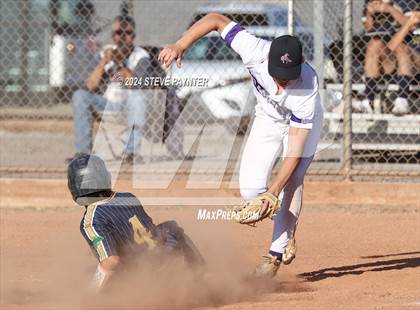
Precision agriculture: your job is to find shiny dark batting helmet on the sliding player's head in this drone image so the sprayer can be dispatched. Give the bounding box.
[67,153,111,205]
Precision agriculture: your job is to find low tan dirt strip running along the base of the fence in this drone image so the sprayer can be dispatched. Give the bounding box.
[0,178,420,209]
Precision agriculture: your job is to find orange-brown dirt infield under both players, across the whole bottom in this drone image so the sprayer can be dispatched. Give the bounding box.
[0,179,420,309]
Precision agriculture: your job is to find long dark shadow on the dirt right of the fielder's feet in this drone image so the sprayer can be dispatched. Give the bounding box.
[299,253,420,282]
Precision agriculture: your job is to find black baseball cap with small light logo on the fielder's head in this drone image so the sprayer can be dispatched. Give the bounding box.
[268,35,303,80]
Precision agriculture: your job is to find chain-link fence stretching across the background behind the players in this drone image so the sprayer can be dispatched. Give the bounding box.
[0,0,420,179]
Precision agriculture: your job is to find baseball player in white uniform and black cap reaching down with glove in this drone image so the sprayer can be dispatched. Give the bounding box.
[159,13,323,277]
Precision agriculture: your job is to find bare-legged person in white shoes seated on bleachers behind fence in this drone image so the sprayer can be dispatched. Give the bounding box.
[361,0,417,114]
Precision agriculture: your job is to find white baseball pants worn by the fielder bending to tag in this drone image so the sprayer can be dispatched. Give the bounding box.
[239,110,323,253]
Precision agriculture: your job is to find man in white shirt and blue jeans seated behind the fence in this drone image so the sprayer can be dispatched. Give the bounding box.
[72,16,153,161]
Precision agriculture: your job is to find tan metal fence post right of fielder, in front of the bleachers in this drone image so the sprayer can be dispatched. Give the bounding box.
[343,0,353,180]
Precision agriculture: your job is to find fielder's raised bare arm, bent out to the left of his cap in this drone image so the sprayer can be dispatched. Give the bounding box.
[159,13,231,67]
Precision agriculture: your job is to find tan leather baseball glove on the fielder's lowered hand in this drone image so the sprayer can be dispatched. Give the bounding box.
[234,192,280,225]
